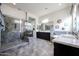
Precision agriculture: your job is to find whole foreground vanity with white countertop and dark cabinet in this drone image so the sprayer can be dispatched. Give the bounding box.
[52,35,79,56]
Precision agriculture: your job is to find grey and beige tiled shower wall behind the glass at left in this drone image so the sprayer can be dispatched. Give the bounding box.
[1,16,20,45]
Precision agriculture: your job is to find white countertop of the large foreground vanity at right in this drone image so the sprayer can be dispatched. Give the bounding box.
[52,35,79,48]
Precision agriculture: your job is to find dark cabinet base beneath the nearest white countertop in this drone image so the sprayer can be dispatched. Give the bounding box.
[54,42,79,56]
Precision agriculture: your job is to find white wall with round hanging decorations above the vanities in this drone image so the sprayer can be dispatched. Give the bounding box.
[38,7,72,31]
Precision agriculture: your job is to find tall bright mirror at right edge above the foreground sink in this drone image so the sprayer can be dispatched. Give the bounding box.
[72,4,79,34]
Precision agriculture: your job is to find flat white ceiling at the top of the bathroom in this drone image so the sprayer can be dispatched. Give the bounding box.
[6,3,71,17]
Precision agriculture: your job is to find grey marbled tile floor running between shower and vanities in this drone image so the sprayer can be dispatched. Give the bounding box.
[0,37,54,56]
